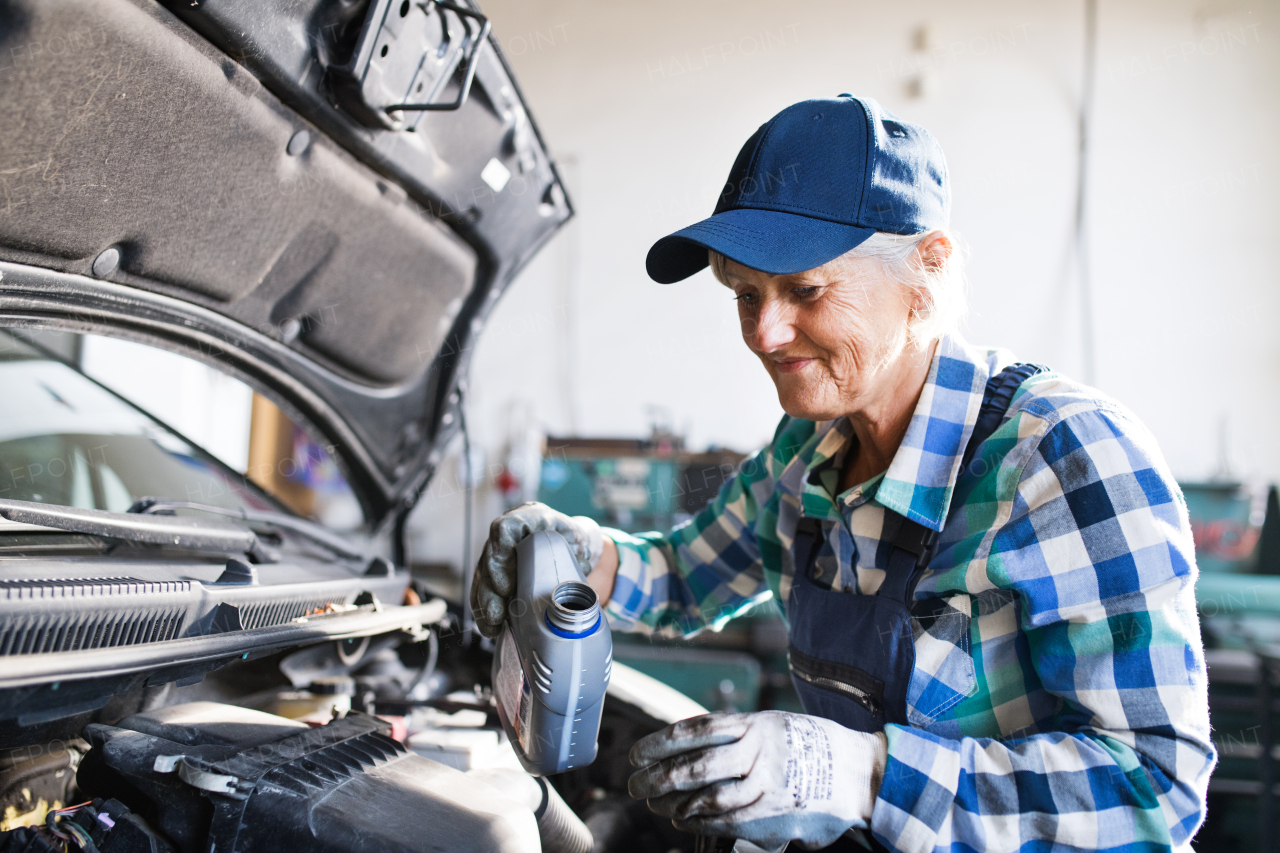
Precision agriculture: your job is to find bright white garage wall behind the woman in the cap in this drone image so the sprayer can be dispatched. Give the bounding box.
[453,0,1280,494]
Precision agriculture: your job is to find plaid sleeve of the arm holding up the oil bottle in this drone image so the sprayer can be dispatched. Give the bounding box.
[604,418,796,637]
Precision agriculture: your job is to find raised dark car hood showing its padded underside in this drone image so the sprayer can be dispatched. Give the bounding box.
[0,0,572,525]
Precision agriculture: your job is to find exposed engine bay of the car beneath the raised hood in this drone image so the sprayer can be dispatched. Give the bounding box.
[0,596,698,853]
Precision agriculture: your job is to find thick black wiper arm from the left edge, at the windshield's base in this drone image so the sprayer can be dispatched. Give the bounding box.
[0,498,279,562]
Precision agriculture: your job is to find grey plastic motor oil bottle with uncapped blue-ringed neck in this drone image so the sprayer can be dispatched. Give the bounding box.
[493,532,613,776]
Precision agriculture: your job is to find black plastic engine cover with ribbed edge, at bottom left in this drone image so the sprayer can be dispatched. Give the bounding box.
[77,702,540,853]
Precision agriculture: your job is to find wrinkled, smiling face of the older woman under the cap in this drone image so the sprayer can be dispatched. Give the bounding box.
[724,257,923,420]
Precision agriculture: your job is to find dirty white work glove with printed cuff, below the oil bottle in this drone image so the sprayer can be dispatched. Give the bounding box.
[627,711,887,850]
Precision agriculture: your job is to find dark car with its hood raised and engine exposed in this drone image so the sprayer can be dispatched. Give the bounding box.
[0,0,690,852]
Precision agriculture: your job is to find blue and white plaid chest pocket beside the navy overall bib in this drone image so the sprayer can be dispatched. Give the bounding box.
[906,594,978,727]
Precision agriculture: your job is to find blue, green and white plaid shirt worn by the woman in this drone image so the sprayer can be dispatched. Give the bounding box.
[608,337,1216,852]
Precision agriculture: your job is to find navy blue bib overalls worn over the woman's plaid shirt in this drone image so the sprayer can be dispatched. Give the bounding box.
[787,364,1047,845]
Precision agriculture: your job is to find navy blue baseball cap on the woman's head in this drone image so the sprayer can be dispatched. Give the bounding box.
[645,95,951,284]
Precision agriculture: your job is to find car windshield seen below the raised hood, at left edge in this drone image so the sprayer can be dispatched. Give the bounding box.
[0,332,279,512]
